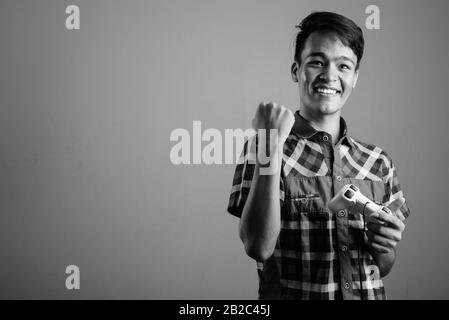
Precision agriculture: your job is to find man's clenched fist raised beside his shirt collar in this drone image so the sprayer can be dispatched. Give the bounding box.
[252,102,295,144]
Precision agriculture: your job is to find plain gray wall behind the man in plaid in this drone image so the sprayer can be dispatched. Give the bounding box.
[0,0,449,299]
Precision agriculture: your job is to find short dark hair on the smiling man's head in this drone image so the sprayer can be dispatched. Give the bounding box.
[295,11,365,69]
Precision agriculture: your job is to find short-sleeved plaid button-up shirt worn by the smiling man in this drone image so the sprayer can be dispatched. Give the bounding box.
[228,111,410,300]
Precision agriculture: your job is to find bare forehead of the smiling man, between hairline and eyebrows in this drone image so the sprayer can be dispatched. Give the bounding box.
[301,31,357,63]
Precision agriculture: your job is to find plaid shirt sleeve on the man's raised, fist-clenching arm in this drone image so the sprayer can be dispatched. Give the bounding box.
[227,135,284,218]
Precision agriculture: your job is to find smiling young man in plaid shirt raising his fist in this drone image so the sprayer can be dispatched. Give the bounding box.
[228,12,410,299]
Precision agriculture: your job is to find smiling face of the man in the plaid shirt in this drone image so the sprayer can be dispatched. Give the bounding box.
[292,32,358,117]
